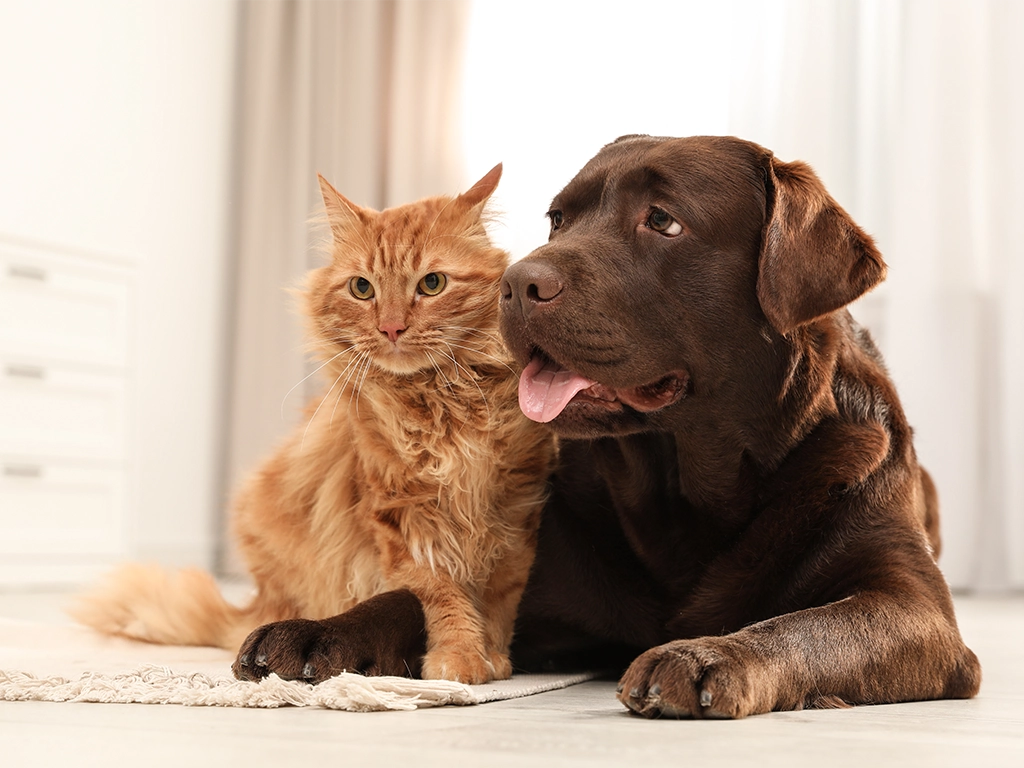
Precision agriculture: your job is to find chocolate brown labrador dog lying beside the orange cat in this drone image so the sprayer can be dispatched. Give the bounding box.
[236,136,981,718]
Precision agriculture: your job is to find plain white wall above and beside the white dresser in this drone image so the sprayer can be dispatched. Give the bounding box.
[0,0,237,564]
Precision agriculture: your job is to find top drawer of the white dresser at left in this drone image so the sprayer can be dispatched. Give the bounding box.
[0,244,130,368]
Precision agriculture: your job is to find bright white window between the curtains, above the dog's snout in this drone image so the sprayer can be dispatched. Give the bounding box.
[462,0,735,259]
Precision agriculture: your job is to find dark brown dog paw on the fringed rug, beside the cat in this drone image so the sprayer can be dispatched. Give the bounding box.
[231,590,426,683]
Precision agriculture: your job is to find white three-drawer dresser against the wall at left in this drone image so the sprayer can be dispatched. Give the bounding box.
[0,238,134,587]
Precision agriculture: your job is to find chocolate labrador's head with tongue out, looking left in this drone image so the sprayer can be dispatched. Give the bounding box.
[501,136,885,436]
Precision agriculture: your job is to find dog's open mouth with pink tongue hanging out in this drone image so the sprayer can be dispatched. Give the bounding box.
[519,353,688,423]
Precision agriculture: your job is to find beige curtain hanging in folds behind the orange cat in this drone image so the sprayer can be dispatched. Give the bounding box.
[224,0,468,569]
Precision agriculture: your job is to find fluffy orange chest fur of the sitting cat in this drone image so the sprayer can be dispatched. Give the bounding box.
[337,371,524,582]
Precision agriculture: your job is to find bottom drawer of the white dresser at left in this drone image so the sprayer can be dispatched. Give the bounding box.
[0,457,127,555]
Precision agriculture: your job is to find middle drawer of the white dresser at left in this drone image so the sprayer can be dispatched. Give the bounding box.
[0,355,127,461]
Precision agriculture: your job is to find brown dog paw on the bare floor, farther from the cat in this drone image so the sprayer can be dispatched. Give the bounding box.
[618,637,772,718]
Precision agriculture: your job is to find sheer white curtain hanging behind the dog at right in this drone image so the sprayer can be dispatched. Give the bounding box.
[732,0,1024,590]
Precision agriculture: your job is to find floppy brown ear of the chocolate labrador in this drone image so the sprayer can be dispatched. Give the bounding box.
[758,157,886,334]
